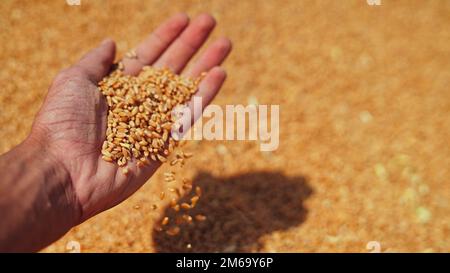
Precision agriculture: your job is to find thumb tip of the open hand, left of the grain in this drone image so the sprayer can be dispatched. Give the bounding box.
[75,39,116,84]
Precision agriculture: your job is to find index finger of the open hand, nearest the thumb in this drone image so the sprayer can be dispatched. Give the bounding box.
[123,13,189,75]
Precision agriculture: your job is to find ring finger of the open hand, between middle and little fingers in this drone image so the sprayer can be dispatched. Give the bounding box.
[186,38,232,78]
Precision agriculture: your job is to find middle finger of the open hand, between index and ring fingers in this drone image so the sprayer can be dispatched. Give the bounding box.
[155,14,216,73]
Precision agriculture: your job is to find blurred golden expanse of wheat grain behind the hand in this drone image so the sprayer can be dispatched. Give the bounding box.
[0,0,450,252]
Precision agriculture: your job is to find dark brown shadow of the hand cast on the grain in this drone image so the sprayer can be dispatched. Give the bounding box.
[153,172,313,252]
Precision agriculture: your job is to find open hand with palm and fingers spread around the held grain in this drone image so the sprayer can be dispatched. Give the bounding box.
[32,14,231,222]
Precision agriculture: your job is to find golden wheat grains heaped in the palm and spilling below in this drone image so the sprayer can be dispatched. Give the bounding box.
[98,64,205,235]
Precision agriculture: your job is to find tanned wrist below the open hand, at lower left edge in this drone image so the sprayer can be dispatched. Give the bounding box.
[0,130,80,252]
